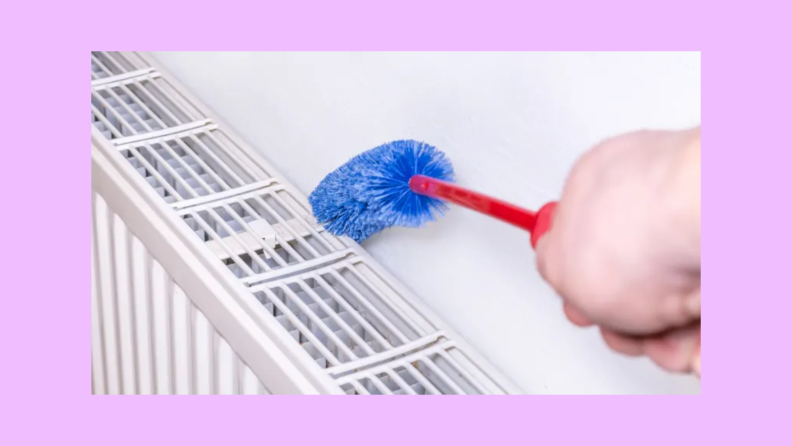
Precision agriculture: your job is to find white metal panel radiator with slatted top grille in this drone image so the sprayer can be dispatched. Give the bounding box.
[91,52,521,394]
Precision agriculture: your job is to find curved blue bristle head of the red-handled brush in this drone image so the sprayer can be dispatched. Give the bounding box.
[308,140,454,243]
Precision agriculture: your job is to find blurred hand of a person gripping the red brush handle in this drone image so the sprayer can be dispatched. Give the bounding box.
[537,127,701,377]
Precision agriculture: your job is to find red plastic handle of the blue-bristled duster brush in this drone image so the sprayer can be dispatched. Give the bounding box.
[410,175,556,248]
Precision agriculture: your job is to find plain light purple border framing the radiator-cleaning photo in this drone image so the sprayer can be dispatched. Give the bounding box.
[7,0,792,446]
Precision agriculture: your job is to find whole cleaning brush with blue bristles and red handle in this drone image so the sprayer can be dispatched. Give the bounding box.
[308,140,556,246]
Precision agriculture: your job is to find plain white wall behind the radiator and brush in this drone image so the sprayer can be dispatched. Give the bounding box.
[155,53,701,393]
